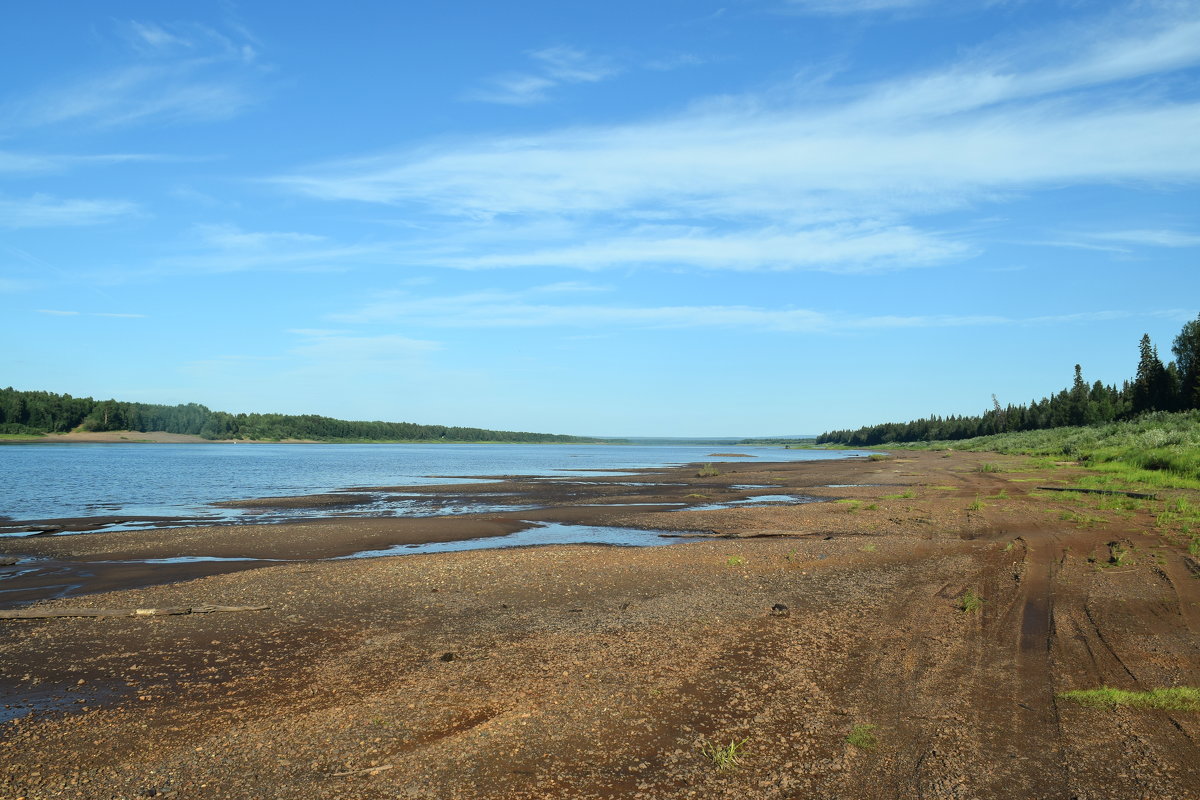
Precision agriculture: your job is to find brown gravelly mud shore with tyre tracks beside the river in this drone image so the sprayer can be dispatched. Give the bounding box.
[0,453,1200,800]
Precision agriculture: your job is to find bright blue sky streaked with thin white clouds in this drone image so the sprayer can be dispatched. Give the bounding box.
[0,0,1200,437]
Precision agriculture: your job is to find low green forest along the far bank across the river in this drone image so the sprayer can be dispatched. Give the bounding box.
[0,386,595,443]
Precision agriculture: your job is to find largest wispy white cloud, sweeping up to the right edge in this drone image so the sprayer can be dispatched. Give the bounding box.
[271,6,1200,278]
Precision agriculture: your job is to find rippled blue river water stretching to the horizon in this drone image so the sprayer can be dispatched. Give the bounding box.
[0,444,866,522]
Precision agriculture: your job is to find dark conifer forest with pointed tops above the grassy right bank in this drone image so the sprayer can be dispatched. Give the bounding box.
[817,317,1200,446]
